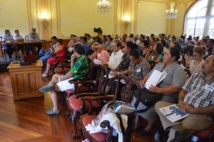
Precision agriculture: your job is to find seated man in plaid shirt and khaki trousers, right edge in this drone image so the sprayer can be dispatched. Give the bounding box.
[155,55,214,142]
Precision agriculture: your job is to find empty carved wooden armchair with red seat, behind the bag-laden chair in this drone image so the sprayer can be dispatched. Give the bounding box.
[68,65,108,139]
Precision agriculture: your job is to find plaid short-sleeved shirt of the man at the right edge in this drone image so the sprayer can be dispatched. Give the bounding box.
[183,73,214,108]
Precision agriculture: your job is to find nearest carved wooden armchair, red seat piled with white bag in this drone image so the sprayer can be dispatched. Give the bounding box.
[80,75,141,142]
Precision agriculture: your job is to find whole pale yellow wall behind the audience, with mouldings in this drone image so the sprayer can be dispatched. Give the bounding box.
[0,0,195,39]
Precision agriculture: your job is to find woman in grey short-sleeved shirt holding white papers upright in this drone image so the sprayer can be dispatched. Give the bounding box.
[134,48,185,135]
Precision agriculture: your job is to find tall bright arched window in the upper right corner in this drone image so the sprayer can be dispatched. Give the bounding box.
[184,0,214,38]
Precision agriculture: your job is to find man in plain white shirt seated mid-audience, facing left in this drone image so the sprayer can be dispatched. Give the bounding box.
[104,40,123,70]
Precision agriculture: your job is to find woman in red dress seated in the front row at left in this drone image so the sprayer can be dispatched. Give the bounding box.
[42,39,65,77]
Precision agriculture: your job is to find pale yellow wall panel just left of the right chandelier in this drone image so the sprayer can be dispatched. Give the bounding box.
[136,0,167,35]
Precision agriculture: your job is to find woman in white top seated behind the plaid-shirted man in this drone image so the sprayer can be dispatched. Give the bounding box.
[190,46,205,74]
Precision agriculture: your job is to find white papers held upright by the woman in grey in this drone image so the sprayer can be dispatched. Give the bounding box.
[145,70,167,90]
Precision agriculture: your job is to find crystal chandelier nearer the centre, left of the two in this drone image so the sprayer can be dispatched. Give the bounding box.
[97,0,111,14]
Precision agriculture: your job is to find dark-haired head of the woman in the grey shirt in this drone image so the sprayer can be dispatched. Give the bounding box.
[163,48,180,64]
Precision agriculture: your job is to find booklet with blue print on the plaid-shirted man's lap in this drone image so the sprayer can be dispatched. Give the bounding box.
[159,104,189,122]
